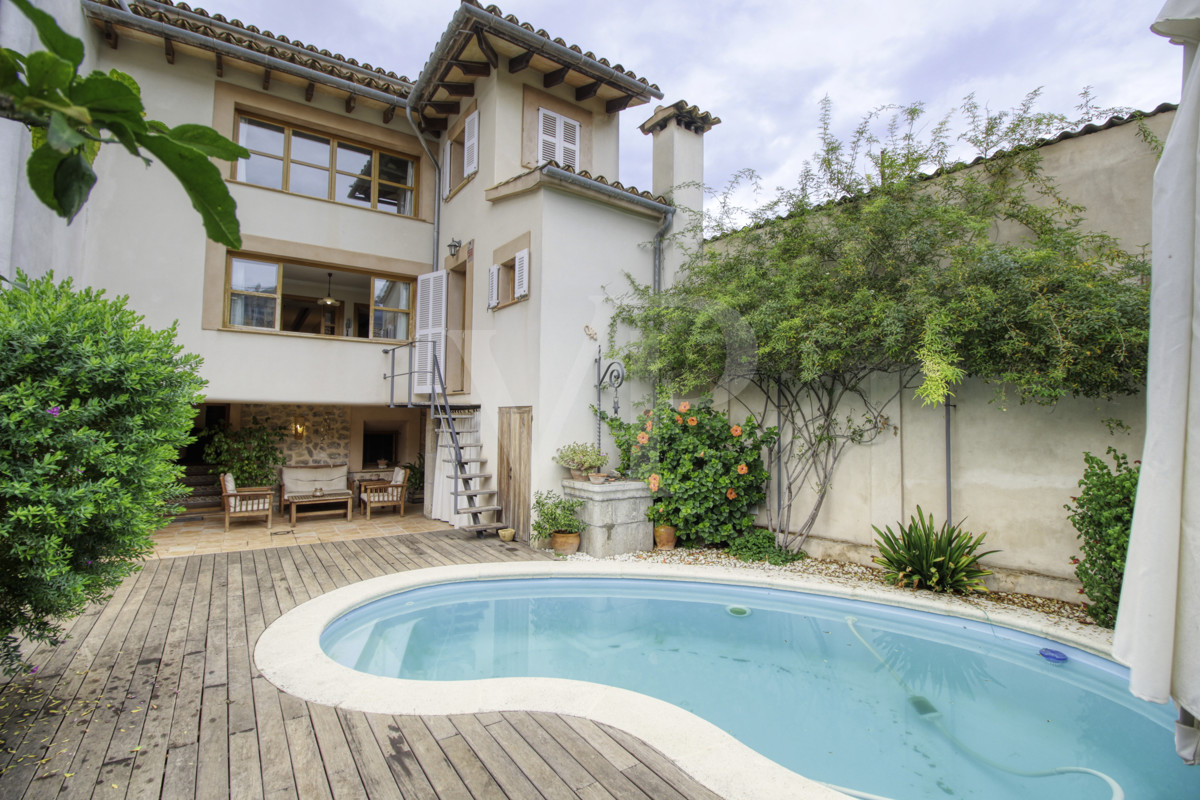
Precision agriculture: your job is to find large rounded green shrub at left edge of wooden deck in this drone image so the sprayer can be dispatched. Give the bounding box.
[0,276,204,674]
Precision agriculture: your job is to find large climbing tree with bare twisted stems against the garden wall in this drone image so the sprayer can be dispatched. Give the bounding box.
[613,87,1148,548]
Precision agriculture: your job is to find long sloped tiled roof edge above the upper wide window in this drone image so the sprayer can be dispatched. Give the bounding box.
[96,0,413,97]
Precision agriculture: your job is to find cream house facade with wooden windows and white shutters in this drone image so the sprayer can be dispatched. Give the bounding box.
[0,0,719,533]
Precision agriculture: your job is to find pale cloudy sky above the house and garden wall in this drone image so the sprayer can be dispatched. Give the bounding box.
[193,0,1182,206]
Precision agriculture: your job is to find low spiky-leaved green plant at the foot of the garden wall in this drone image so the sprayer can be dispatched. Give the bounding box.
[871,506,1000,594]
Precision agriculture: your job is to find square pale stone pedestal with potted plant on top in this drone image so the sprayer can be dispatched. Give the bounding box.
[563,480,654,558]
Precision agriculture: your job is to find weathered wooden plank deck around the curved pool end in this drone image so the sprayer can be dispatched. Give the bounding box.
[0,531,719,800]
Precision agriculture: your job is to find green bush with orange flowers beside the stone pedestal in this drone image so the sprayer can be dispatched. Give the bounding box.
[600,396,775,545]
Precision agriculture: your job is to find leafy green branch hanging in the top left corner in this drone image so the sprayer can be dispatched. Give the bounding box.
[0,0,250,248]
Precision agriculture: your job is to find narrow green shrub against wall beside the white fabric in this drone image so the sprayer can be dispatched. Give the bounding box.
[1063,447,1141,627]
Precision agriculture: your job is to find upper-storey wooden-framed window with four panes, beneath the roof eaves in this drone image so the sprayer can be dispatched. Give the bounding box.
[236,114,418,217]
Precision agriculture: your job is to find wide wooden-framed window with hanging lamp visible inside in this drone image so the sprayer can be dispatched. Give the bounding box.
[224,254,413,342]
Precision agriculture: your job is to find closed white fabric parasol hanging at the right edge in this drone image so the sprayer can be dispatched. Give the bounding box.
[1112,0,1200,764]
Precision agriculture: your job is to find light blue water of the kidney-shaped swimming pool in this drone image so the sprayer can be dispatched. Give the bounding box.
[320,578,1200,800]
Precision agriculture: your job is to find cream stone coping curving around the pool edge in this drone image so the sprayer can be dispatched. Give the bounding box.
[254,561,1111,800]
